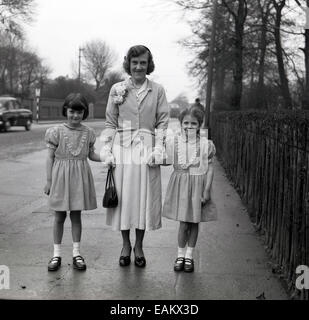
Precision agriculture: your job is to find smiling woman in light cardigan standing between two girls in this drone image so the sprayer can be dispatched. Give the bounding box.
[101,45,169,267]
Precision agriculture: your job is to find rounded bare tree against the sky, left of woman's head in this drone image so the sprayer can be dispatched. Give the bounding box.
[83,40,116,91]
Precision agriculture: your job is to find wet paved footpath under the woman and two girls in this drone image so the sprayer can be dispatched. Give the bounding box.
[0,119,288,300]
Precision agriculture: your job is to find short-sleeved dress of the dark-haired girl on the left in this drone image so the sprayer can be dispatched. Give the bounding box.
[45,123,97,211]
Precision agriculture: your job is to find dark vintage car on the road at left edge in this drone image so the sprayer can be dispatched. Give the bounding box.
[0,97,33,131]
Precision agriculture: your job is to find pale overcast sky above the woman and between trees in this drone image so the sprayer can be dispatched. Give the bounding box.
[26,0,197,102]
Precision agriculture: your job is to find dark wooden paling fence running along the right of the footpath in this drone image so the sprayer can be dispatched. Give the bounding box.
[211,111,309,300]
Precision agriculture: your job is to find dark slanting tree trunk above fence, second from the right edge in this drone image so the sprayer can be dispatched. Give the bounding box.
[273,0,292,109]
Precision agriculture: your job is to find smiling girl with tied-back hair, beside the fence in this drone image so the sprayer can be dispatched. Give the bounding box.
[163,108,216,272]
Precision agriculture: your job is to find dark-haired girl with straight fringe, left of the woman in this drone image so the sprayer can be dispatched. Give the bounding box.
[44,93,101,271]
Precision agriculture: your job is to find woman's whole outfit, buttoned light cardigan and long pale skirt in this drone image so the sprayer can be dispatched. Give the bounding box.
[101,79,168,231]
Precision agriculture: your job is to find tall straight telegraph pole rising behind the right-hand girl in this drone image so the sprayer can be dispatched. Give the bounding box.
[204,0,218,139]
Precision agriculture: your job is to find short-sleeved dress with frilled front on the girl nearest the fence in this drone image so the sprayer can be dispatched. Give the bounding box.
[163,135,217,223]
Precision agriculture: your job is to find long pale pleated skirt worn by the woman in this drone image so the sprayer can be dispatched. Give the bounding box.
[106,134,162,230]
